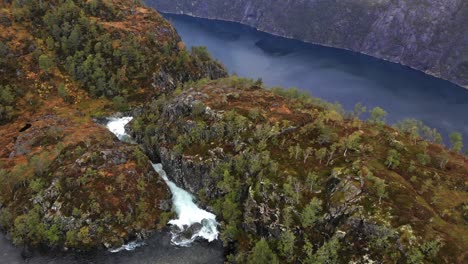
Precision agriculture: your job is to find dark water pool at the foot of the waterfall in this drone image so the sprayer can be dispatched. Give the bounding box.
[0,228,224,264]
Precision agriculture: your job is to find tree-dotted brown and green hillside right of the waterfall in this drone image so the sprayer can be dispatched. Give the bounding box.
[131,76,468,263]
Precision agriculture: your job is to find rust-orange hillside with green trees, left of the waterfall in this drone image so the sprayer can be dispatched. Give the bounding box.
[0,0,226,250]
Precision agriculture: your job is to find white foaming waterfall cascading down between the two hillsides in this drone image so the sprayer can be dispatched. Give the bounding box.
[107,117,219,246]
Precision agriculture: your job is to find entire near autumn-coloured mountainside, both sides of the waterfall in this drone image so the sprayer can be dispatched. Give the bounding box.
[0,0,468,263]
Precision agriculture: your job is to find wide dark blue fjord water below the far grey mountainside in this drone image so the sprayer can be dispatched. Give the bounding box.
[164,14,468,142]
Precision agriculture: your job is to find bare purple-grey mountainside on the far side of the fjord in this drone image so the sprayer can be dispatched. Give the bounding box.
[150,0,468,87]
